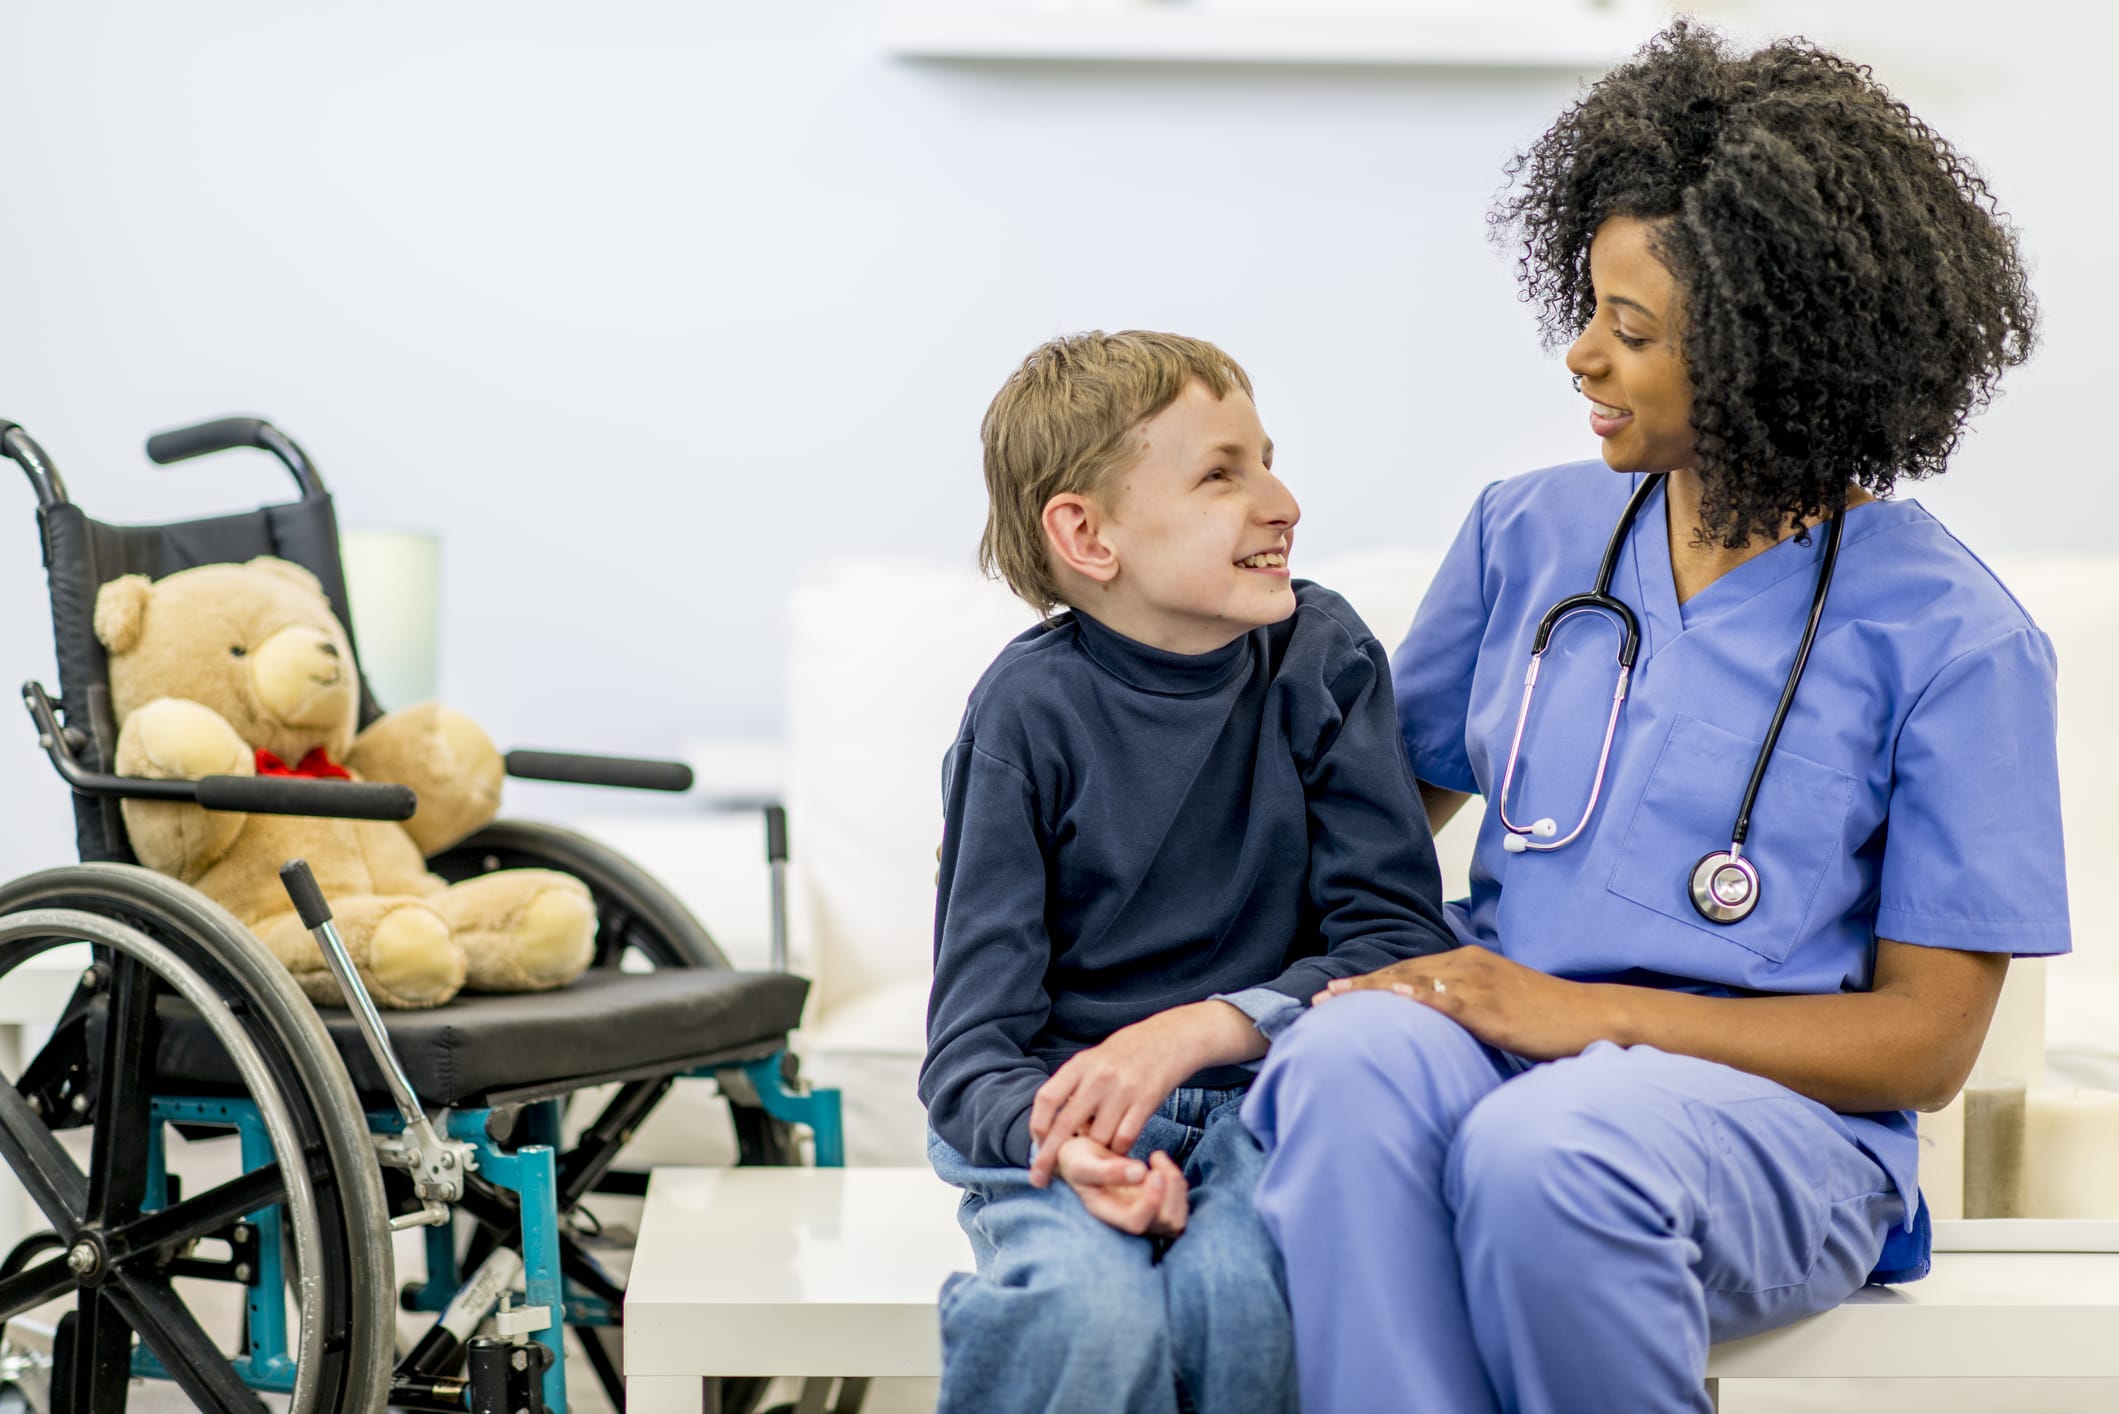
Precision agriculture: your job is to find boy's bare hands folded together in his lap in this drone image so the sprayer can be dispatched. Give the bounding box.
[1030,1001,1265,1238]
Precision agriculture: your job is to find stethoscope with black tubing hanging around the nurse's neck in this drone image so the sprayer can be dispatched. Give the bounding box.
[1496,473,1846,922]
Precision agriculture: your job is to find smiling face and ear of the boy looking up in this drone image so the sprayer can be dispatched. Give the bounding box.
[1047,382,1301,653]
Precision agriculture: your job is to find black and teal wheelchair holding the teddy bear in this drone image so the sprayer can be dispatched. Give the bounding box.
[0,418,843,1414]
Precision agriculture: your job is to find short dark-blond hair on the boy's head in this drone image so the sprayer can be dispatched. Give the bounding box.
[979,329,1252,613]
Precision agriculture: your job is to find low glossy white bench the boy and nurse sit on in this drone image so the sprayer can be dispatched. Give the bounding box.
[625,1168,2119,1414]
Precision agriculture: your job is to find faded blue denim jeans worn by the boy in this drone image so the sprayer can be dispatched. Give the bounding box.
[928,1090,1297,1414]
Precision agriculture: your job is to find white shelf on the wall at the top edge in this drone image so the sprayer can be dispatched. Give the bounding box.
[884,0,1663,70]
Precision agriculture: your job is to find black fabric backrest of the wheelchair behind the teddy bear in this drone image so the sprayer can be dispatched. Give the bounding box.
[38,460,381,863]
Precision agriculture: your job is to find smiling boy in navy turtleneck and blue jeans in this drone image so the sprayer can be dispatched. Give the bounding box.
[920,333,1454,1414]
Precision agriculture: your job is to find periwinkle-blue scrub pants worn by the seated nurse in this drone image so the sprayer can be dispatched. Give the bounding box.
[1244,992,1905,1414]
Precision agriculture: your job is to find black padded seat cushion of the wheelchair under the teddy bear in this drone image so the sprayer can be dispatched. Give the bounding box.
[111,967,809,1109]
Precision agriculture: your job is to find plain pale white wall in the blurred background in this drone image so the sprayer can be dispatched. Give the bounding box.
[0,0,2119,878]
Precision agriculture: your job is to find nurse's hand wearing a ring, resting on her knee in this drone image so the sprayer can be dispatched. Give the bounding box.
[1312,943,1615,1060]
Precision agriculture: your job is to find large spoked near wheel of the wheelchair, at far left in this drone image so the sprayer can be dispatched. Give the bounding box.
[0,865,394,1414]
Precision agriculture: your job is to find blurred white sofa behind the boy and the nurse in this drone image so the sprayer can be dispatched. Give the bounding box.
[786,549,2119,1164]
